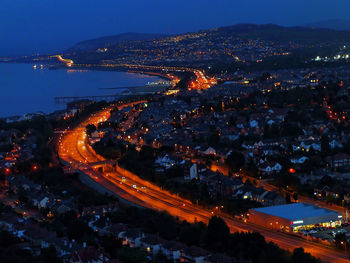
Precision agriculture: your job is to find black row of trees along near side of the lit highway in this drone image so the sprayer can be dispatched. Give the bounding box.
[111,207,320,263]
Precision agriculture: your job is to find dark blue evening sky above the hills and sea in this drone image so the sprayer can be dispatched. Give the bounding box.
[0,0,350,56]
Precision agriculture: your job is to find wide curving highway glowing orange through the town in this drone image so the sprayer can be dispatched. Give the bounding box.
[58,105,350,263]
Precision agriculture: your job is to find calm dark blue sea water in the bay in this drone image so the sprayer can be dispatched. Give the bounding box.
[0,63,159,117]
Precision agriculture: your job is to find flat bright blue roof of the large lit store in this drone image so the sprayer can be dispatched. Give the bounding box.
[251,203,340,221]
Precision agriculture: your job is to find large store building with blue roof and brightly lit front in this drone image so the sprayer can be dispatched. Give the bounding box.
[249,203,342,232]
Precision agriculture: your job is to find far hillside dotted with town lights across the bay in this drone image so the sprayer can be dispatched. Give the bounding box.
[37,24,350,66]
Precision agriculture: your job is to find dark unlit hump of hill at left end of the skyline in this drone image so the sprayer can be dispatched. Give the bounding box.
[67,32,167,52]
